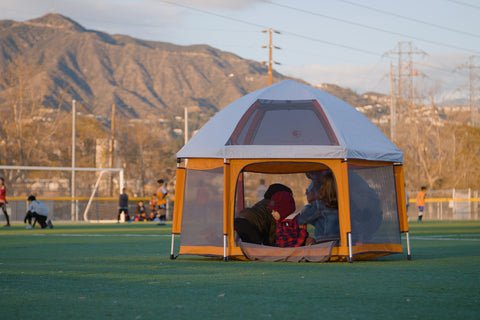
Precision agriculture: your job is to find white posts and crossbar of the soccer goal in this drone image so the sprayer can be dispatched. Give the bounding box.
[0,165,125,222]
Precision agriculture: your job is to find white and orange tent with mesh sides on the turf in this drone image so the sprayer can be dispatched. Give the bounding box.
[171,80,410,262]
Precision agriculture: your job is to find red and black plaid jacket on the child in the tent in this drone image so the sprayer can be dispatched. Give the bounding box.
[275,215,308,247]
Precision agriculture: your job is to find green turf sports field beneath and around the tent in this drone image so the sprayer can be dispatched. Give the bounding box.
[0,221,480,320]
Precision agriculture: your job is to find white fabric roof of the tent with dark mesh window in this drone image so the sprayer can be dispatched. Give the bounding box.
[177,80,403,162]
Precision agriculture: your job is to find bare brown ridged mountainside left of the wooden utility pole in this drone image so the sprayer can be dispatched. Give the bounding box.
[0,13,292,118]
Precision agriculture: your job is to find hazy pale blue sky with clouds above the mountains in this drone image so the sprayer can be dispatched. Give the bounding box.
[0,0,480,98]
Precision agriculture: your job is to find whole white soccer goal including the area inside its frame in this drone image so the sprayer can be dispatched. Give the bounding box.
[0,166,125,222]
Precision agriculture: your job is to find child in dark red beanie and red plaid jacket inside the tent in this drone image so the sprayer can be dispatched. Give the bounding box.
[268,191,308,247]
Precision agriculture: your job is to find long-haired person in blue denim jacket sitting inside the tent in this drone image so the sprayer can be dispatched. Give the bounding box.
[298,171,340,242]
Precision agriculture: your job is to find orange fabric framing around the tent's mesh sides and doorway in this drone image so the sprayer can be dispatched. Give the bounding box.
[170,158,411,262]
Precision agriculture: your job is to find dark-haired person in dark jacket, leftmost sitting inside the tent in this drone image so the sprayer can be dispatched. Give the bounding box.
[234,183,292,247]
